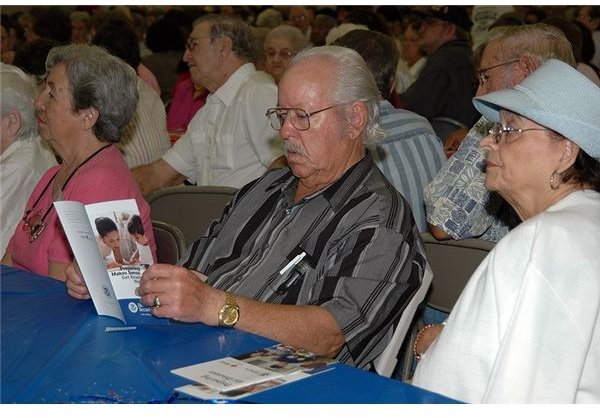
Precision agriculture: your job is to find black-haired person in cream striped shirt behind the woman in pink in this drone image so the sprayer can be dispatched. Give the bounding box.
[92,19,171,168]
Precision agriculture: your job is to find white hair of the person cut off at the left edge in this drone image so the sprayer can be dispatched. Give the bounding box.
[0,64,37,140]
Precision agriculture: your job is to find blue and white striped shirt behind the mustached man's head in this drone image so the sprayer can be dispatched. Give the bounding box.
[371,100,446,232]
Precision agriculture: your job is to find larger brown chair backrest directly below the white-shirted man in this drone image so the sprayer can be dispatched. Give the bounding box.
[146,186,237,245]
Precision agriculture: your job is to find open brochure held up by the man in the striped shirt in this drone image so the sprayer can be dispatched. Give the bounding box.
[54,199,168,325]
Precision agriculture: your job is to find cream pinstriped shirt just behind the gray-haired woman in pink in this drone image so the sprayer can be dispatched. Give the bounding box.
[117,77,171,168]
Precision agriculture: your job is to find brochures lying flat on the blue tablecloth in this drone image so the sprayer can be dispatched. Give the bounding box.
[171,344,335,400]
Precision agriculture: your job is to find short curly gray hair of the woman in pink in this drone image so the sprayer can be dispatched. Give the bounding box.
[46,44,138,142]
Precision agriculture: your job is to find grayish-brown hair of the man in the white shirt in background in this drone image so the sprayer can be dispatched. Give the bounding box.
[194,14,256,62]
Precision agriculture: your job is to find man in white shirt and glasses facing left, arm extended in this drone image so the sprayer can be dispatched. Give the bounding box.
[133,15,282,196]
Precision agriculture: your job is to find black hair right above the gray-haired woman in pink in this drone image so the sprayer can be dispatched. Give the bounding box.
[92,18,142,70]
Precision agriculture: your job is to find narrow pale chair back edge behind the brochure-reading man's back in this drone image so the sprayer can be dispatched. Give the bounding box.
[374,263,433,377]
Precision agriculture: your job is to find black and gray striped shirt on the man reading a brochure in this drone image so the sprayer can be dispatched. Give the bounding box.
[182,155,426,369]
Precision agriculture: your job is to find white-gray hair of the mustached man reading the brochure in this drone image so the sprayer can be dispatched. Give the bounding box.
[289,46,386,144]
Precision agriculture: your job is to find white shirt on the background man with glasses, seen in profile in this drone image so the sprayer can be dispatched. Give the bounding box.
[163,63,282,188]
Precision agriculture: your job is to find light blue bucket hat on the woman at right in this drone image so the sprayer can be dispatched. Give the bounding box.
[473,59,600,160]
